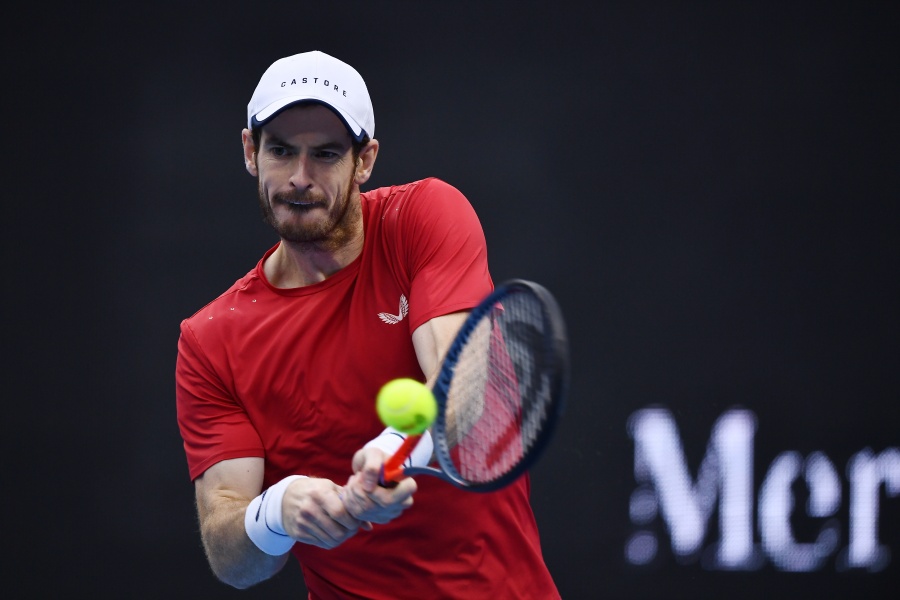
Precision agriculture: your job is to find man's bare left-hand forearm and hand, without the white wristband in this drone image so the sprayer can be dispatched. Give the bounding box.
[194,458,368,589]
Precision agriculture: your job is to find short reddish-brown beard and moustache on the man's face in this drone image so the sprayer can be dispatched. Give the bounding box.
[257,179,360,249]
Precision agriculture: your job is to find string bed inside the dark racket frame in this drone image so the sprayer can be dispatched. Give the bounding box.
[447,293,552,482]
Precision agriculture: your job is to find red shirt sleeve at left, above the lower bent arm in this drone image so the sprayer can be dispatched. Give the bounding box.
[175,320,265,480]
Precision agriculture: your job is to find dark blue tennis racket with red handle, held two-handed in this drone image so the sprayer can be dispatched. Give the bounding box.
[382,279,569,492]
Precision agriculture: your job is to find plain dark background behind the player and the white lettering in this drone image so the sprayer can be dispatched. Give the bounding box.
[3,0,900,598]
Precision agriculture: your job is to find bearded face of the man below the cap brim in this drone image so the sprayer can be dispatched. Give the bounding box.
[255,105,361,249]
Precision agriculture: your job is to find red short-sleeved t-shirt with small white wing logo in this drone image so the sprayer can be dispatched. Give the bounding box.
[175,179,558,599]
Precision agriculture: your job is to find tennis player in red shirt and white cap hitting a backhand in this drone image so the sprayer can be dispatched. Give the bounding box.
[176,51,559,598]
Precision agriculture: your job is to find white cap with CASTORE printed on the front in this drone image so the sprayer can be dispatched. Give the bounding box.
[247,50,375,141]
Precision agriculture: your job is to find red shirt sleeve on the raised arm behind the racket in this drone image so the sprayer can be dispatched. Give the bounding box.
[399,179,493,330]
